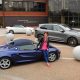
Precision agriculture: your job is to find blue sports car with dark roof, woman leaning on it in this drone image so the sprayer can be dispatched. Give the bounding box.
[0,39,60,69]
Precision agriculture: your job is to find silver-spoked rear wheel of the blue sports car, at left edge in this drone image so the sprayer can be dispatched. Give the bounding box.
[0,58,11,69]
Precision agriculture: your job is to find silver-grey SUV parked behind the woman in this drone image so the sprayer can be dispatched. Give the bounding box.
[35,24,80,46]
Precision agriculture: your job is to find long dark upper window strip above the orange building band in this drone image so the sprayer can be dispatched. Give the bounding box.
[4,1,46,12]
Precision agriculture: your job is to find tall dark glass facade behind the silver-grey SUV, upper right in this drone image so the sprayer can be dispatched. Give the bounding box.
[49,0,80,27]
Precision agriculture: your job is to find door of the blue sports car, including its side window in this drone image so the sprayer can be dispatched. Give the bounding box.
[17,45,41,62]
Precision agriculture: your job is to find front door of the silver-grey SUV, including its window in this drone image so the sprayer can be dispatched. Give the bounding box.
[50,24,67,42]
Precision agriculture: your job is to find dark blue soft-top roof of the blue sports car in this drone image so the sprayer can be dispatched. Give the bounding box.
[11,39,33,46]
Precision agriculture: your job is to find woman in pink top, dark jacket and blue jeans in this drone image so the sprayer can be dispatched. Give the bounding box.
[38,32,49,66]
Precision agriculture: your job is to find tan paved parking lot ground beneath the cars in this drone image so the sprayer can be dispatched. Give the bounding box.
[0,34,80,80]
